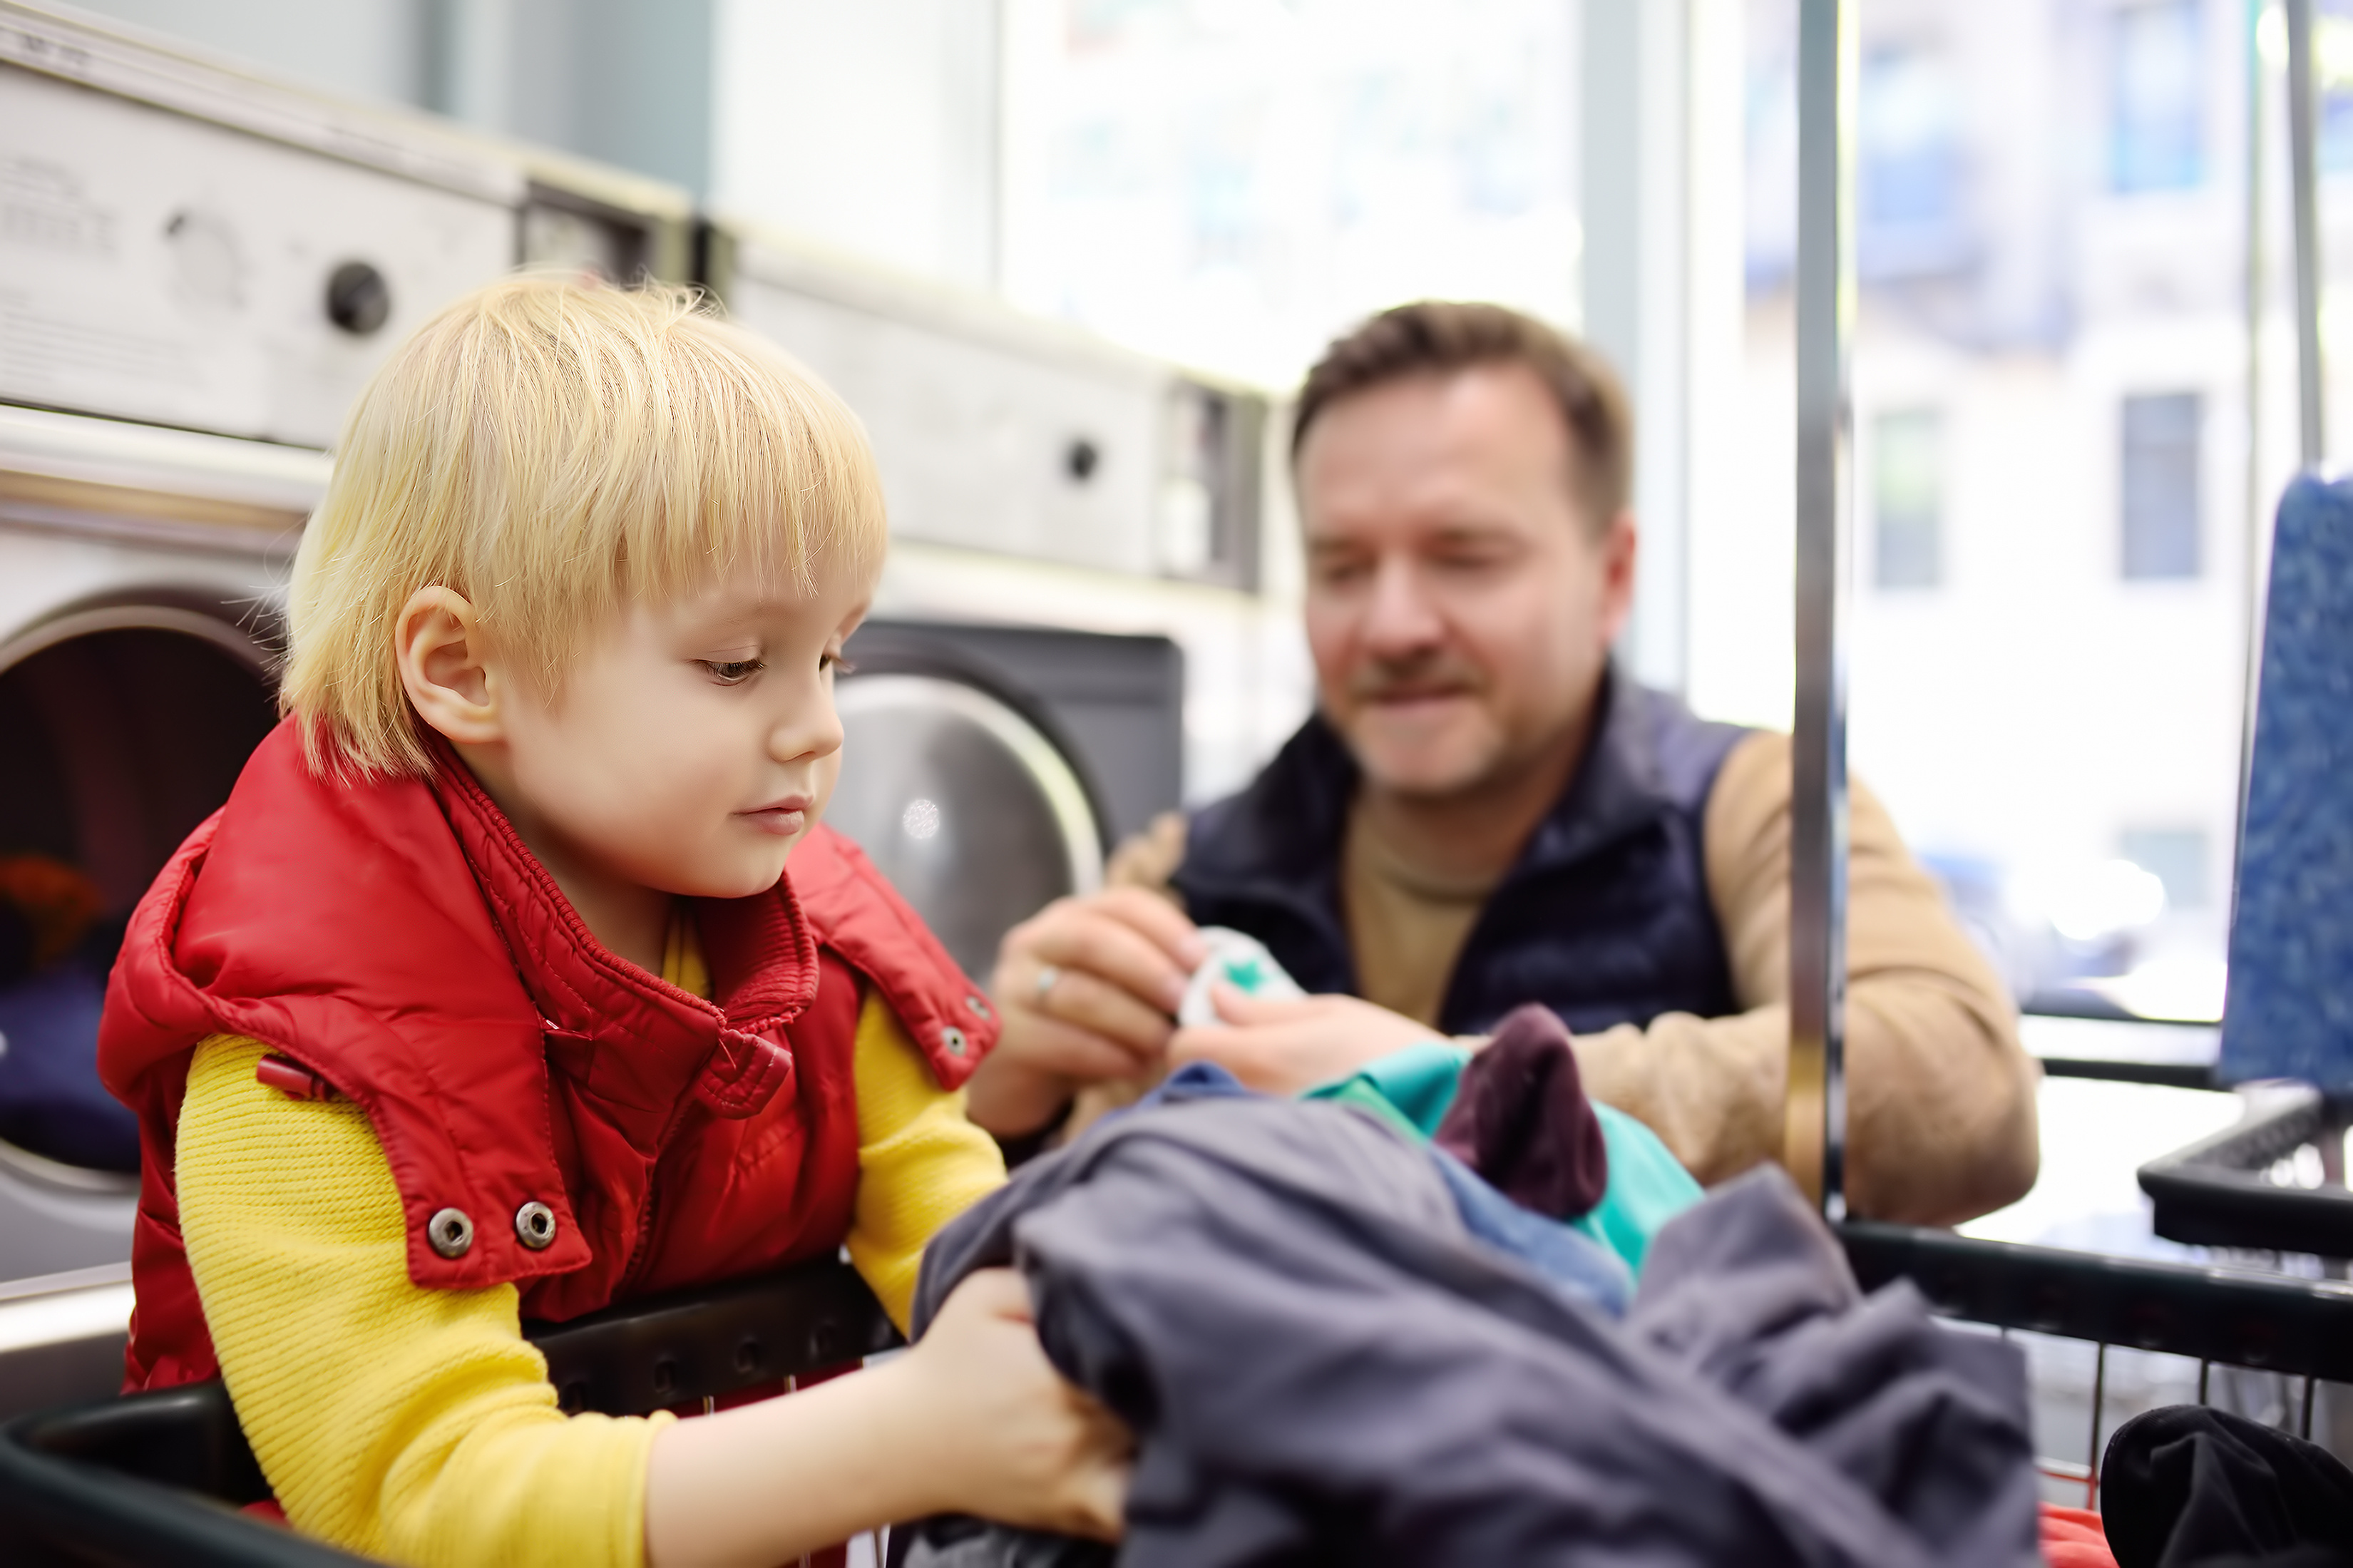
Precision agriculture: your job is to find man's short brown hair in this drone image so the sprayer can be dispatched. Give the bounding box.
[1292,299,1633,532]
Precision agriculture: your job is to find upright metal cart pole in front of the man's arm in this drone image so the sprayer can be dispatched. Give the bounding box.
[1783,0,1859,1222]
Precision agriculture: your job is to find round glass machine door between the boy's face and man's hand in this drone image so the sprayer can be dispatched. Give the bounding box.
[826,673,1104,982]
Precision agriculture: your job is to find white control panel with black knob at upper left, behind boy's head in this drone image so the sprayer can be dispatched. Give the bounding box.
[0,66,516,447]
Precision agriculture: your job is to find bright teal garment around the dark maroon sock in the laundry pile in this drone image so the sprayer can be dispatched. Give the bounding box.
[1301,1040,1701,1276]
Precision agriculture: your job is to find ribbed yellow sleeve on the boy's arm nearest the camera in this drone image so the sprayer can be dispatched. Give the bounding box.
[177,1036,671,1568]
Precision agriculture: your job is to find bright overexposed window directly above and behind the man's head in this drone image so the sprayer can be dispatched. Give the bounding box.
[998,0,1584,386]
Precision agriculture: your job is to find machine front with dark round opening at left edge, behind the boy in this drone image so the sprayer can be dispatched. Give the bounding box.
[0,407,327,1281]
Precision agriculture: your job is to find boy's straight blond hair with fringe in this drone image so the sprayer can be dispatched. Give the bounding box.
[277,275,885,774]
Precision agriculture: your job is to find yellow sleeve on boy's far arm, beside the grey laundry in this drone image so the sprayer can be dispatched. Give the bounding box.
[849,993,1005,1333]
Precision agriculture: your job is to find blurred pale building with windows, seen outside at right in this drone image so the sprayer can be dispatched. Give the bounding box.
[1731,0,2353,1017]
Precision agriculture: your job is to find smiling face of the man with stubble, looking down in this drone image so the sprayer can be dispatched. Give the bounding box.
[1299,365,1636,796]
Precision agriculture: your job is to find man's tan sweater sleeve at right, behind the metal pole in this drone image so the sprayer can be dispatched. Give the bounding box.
[1577,734,2040,1224]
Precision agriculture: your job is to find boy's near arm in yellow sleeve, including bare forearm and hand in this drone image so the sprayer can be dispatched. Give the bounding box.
[179,1015,1127,1568]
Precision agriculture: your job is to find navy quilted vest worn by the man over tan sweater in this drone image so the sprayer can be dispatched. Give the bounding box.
[1174,671,1746,1033]
